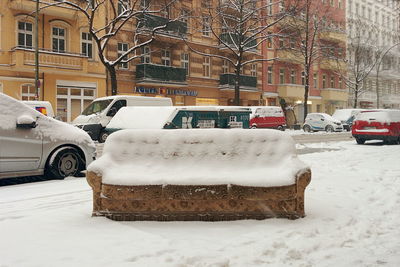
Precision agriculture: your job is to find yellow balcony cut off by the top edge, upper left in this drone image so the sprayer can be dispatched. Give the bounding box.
[8,0,77,19]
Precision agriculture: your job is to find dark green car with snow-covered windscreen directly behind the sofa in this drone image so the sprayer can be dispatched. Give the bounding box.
[104,106,251,141]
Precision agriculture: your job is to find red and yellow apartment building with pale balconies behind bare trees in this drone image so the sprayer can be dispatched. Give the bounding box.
[262,0,348,122]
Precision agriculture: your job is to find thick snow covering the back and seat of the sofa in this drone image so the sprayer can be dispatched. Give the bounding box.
[88,129,307,186]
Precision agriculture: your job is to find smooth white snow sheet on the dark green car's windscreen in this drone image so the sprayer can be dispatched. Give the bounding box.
[107,107,177,129]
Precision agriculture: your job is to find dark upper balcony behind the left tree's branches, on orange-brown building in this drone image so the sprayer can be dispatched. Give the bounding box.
[137,14,187,37]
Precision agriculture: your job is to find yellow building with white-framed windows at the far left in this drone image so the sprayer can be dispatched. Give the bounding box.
[0,0,106,122]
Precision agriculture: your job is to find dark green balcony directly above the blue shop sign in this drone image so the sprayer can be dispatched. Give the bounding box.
[136,64,186,83]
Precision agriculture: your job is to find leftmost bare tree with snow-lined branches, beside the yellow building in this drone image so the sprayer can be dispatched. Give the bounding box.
[42,0,178,95]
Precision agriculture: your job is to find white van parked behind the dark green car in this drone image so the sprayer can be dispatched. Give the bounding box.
[72,95,172,143]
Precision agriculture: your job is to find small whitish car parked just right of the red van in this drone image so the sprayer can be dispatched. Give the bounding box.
[303,113,343,132]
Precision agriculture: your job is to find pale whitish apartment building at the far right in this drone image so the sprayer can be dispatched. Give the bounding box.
[346,0,400,108]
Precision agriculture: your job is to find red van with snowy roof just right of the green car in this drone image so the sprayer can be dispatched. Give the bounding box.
[250,106,286,131]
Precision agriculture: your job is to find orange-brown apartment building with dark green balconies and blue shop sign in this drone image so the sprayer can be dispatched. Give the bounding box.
[109,0,261,106]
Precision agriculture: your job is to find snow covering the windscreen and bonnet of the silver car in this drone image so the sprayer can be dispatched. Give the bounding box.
[0,93,94,146]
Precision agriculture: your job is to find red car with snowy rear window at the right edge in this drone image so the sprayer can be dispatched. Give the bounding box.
[352,110,400,144]
